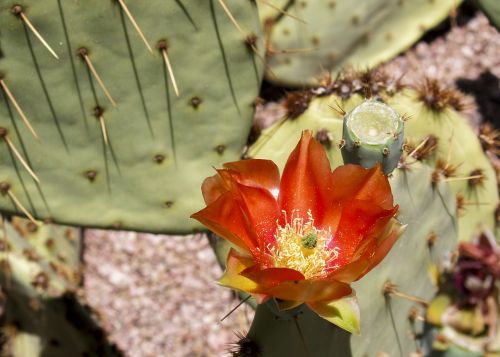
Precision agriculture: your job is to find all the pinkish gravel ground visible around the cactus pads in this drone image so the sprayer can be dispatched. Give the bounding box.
[85,9,500,357]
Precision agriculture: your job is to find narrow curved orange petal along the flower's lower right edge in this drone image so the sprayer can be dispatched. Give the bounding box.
[330,218,405,283]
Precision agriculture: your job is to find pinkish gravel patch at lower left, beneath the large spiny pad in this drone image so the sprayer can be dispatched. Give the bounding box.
[85,230,252,357]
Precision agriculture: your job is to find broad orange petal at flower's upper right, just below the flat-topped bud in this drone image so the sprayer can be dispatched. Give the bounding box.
[331,164,393,209]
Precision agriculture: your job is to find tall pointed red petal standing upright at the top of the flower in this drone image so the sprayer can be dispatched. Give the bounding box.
[279,131,331,221]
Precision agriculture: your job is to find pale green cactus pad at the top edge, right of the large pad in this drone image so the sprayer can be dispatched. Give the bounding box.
[259,0,460,86]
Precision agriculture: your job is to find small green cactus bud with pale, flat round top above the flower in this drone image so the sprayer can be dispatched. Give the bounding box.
[341,100,404,175]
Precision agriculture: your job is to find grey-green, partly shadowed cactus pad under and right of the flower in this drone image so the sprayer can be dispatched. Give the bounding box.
[219,163,457,357]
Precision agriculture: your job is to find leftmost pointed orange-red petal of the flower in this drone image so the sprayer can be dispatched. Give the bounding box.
[191,192,259,254]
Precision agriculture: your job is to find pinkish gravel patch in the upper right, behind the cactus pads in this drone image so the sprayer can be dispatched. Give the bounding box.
[382,14,500,127]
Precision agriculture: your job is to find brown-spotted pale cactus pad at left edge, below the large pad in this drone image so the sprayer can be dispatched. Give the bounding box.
[0,218,82,298]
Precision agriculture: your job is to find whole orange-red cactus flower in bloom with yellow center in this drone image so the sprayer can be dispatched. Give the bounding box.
[192,131,402,332]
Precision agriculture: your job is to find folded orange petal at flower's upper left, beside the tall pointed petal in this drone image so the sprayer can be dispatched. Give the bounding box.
[224,159,280,197]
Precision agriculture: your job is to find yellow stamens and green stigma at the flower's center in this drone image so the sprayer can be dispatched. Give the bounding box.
[269,210,339,279]
